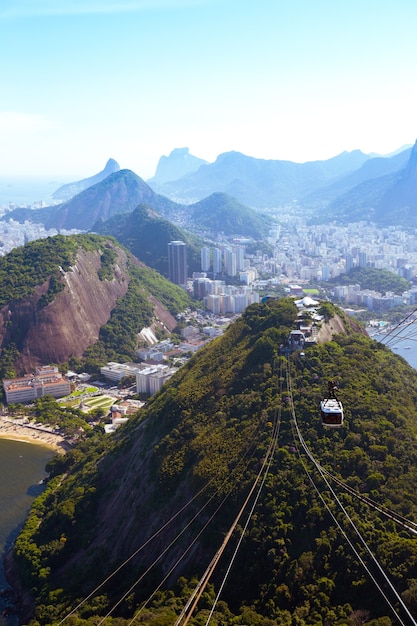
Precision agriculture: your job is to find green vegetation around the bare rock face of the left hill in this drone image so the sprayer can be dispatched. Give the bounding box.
[0,229,191,378]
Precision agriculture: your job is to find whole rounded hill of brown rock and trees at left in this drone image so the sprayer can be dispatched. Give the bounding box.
[0,235,190,378]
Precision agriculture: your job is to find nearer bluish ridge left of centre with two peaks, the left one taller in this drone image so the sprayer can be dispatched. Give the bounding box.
[3,170,271,250]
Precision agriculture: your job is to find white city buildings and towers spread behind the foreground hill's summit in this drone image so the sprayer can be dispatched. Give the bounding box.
[170,219,417,314]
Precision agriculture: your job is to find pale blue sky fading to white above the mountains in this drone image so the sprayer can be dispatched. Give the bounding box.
[0,0,417,179]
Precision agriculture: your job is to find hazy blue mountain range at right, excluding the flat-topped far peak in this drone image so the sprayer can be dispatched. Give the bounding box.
[148,142,417,226]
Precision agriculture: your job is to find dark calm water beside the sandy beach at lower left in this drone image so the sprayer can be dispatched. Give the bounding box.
[0,439,55,626]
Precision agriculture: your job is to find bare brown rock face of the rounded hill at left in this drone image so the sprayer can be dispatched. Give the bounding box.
[0,248,129,373]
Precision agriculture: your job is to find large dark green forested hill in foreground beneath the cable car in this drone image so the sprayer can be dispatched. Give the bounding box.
[10,299,417,626]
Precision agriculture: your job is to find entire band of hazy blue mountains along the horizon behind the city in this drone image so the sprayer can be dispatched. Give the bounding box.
[3,141,417,239]
